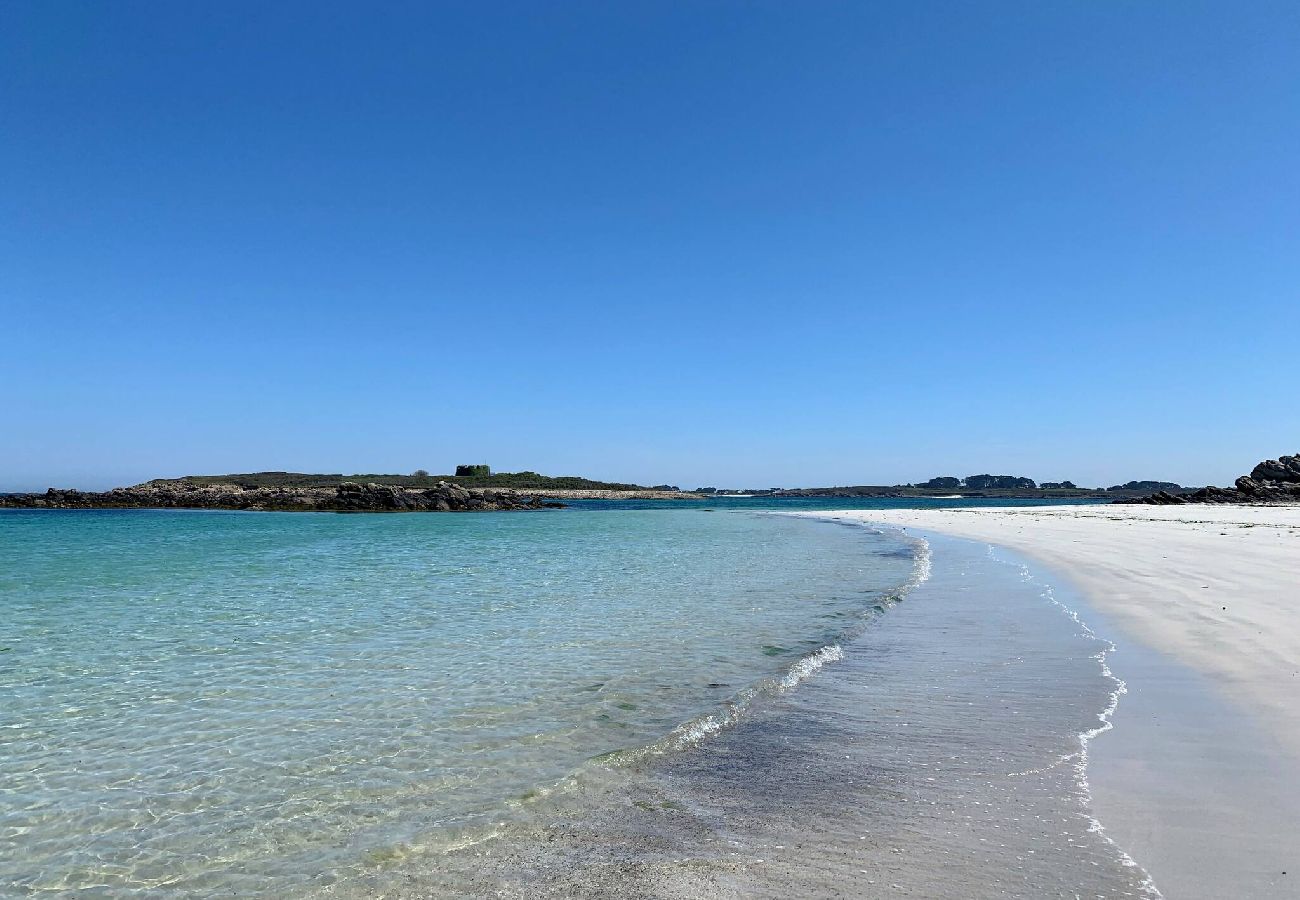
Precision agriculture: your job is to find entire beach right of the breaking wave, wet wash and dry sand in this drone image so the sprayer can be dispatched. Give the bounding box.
[317,507,1300,900]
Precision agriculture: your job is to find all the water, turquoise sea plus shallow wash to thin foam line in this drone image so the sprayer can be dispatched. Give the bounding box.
[0,501,1144,897]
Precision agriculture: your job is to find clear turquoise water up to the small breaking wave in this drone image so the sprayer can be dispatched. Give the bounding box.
[0,510,914,896]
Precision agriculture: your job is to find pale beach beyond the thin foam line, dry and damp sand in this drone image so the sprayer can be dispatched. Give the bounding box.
[800,506,1300,897]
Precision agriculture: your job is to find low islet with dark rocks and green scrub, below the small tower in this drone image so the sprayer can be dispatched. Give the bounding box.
[0,480,559,512]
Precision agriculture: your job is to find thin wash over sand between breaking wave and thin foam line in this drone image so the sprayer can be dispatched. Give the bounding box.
[379,537,1160,900]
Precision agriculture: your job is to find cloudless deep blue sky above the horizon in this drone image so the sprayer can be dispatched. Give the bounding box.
[0,0,1300,489]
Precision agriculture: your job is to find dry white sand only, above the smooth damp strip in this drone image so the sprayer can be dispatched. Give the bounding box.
[793,506,1300,760]
